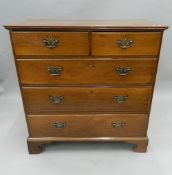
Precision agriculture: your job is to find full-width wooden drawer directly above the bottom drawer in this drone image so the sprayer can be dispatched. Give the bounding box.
[22,87,151,114]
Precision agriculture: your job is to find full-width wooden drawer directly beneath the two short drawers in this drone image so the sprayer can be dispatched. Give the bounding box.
[17,59,157,85]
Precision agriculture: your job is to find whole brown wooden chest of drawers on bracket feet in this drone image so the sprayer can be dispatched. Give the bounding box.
[5,20,167,154]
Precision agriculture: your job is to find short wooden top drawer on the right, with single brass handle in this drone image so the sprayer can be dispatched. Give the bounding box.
[92,32,161,56]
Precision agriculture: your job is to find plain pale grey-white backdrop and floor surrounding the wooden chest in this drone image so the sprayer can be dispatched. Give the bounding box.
[0,0,172,175]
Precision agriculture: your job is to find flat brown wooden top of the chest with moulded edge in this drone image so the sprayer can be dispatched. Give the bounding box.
[4,19,168,30]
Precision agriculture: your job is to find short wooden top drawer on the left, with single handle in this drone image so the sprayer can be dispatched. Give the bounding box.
[12,32,89,56]
